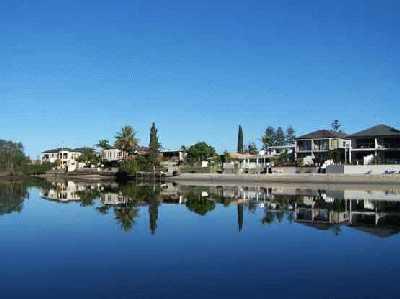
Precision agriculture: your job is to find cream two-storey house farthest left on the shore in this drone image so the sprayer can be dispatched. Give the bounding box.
[40,148,93,171]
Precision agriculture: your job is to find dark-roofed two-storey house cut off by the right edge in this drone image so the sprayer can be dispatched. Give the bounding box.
[349,125,400,164]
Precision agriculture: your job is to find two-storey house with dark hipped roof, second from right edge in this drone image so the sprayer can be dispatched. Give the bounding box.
[295,130,351,164]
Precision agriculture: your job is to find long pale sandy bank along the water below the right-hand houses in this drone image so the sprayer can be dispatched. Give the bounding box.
[166,173,400,184]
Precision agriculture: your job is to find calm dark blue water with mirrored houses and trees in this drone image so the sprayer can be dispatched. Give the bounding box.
[0,182,400,298]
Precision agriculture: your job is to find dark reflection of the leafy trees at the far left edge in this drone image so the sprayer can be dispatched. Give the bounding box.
[0,182,28,215]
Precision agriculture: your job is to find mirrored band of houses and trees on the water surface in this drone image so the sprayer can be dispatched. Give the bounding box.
[0,181,400,237]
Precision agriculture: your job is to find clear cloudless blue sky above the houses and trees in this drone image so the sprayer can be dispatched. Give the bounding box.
[0,0,400,157]
